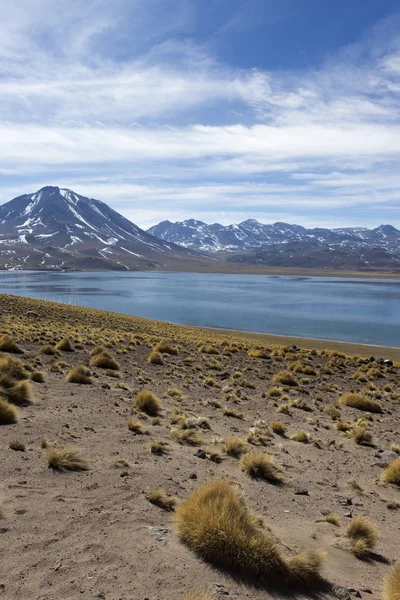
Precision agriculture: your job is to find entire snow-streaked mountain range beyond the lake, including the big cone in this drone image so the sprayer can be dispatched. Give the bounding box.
[0,186,400,272]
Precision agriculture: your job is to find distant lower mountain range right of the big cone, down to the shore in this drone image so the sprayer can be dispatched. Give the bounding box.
[148,219,400,270]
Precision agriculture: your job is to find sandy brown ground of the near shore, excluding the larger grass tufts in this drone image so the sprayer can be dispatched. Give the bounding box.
[0,296,400,600]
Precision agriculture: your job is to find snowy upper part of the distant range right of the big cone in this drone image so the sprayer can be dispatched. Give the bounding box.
[148,219,400,252]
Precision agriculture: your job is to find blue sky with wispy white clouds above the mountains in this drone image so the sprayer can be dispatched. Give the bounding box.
[0,0,400,229]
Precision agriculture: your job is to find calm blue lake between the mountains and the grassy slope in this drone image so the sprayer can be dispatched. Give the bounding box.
[0,271,400,347]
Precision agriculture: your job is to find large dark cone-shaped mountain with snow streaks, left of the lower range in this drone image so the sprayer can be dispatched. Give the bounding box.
[0,186,209,270]
